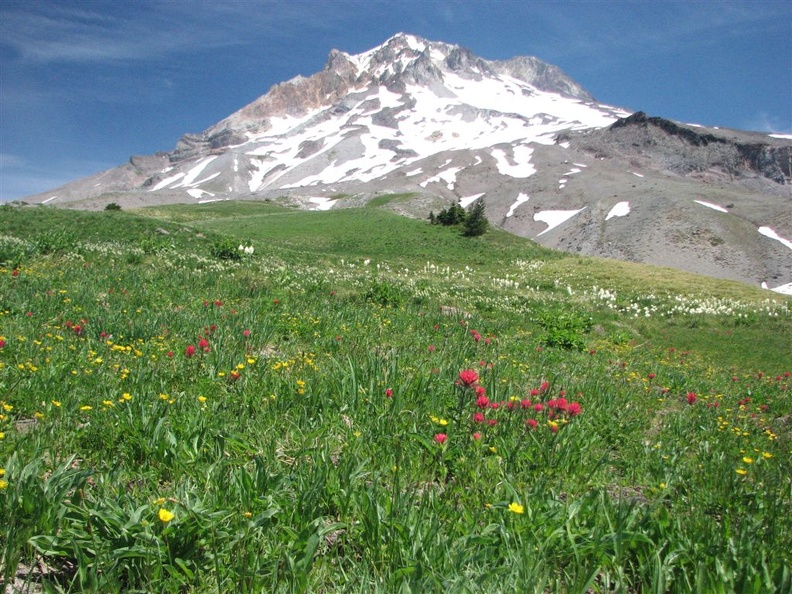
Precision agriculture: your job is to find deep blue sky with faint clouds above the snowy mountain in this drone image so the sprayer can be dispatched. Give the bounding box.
[0,0,792,200]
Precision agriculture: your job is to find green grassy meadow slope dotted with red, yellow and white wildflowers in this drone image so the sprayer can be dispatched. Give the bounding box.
[0,203,792,592]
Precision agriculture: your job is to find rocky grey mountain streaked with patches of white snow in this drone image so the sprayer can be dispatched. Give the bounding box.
[21,34,792,286]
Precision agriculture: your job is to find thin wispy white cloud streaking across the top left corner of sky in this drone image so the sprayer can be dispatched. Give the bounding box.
[0,1,346,63]
